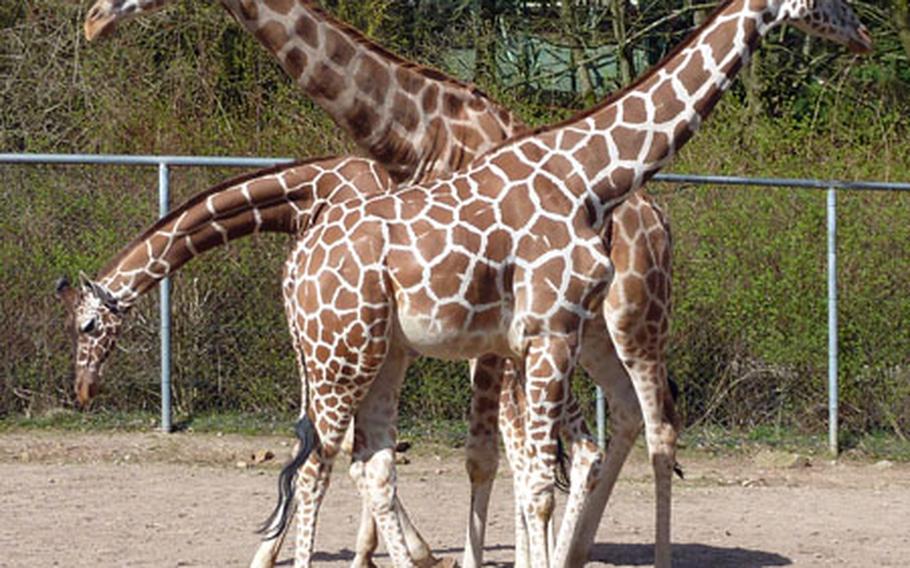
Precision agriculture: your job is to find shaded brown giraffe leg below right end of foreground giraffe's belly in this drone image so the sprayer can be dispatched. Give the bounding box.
[462,356,505,568]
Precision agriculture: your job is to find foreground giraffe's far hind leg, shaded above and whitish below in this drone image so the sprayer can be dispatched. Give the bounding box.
[351,349,426,567]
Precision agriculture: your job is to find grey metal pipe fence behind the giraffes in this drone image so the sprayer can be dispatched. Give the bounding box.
[0,154,910,454]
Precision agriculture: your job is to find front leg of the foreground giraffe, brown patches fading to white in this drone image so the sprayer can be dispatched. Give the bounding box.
[524,333,578,568]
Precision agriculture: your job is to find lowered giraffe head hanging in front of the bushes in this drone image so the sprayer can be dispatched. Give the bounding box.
[57,275,124,406]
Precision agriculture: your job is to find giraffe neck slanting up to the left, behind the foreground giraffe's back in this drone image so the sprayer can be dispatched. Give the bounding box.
[221,0,524,182]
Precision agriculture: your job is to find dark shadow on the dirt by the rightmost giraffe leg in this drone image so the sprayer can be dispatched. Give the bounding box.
[591,543,793,568]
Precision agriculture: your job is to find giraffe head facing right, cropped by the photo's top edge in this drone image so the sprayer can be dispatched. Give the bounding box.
[772,0,872,53]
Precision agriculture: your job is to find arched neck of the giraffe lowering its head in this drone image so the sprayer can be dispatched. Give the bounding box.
[97,158,392,307]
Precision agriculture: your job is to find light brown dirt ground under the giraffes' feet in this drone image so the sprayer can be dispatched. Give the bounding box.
[0,431,910,567]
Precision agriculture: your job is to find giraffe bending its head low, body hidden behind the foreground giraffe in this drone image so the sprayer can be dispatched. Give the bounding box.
[56,153,429,557]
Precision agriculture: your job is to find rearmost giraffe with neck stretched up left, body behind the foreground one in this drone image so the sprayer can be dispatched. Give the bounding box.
[85,0,670,567]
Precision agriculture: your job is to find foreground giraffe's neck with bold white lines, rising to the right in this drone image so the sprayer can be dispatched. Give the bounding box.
[532,0,773,215]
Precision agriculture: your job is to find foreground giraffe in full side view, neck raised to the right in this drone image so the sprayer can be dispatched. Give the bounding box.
[105,0,871,566]
